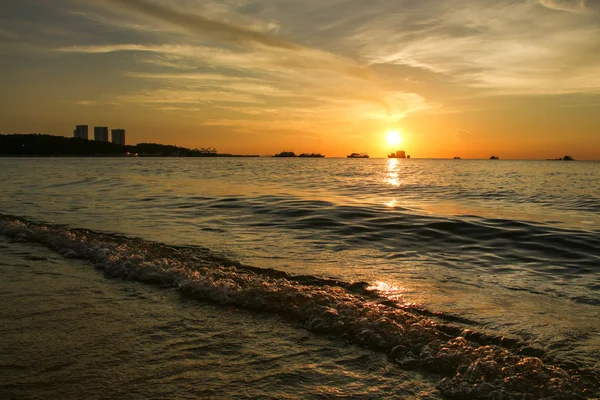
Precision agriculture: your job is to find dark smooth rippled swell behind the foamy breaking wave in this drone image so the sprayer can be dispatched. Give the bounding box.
[190,195,600,305]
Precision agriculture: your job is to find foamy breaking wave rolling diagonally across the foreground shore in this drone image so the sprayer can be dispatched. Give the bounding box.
[0,214,600,399]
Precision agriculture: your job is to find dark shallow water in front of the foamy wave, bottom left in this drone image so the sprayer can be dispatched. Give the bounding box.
[0,237,439,399]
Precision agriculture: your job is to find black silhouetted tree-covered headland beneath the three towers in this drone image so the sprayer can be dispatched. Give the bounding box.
[0,133,248,157]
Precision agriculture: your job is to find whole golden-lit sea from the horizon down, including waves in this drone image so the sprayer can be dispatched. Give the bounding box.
[0,157,600,399]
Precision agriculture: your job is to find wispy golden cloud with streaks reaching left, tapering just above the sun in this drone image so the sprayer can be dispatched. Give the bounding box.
[58,36,431,121]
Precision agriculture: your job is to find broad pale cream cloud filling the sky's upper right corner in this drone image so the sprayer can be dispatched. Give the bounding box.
[349,0,600,95]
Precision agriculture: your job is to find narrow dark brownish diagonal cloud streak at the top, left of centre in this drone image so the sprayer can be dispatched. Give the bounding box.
[104,0,301,50]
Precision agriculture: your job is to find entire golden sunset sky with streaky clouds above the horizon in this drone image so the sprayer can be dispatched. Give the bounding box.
[0,0,600,159]
